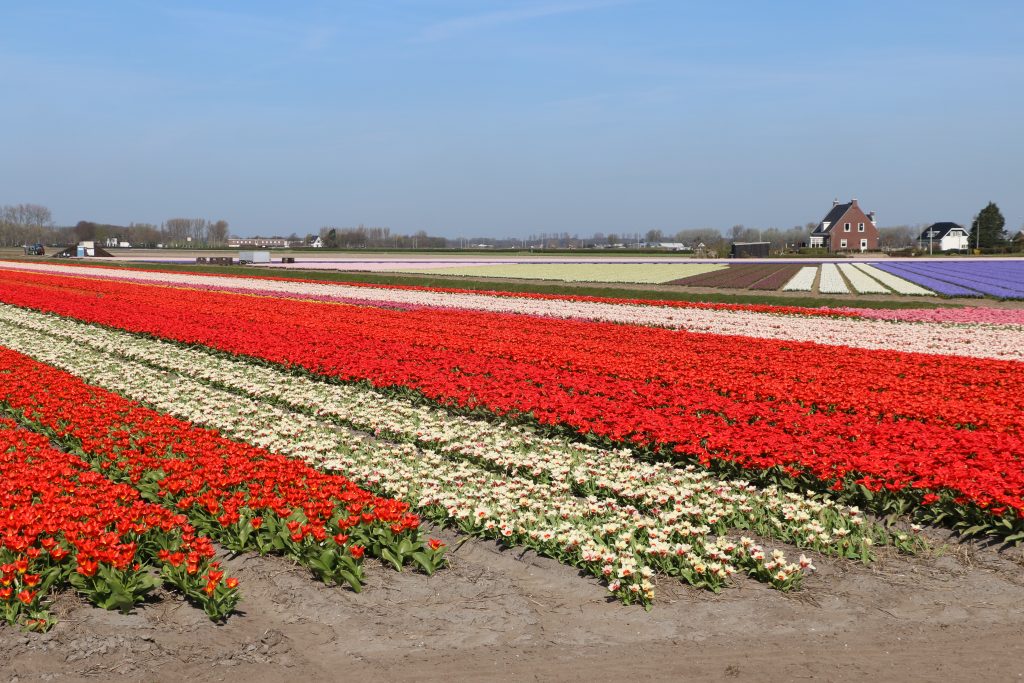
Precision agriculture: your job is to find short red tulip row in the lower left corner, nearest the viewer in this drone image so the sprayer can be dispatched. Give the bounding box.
[0,417,239,631]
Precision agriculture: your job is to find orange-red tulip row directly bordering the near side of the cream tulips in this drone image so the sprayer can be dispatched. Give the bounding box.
[0,347,443,590]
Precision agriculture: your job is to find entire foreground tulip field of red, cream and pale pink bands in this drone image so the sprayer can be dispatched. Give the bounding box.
[0,261,1024,647]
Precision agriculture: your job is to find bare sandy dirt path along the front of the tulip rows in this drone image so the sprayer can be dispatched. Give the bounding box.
[0,532,1024,683]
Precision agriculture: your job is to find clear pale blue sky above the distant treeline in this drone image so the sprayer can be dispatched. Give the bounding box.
[0,0,1024,237]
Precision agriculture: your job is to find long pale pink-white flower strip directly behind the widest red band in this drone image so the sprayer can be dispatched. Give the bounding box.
[0,261,1024,360]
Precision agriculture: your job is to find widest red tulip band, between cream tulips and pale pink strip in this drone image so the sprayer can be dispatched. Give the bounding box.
[0,275,1024,526]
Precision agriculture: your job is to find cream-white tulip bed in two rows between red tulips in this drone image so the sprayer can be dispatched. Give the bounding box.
[3,314,929,602]
